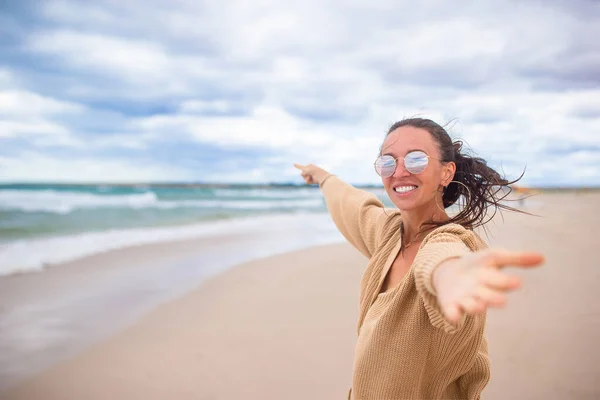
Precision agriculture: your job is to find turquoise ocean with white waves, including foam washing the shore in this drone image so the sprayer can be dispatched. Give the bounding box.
[0,184,389,276]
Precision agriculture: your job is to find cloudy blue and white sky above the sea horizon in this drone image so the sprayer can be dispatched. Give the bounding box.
[0,0,600,186]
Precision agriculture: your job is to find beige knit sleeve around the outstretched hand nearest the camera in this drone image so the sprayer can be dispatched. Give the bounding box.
[413,224,485,333]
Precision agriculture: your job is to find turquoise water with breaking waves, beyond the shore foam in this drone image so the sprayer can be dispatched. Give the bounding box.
[0,185,332,242]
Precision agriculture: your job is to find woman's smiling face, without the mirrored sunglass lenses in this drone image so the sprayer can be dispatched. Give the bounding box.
[381,126,456,211]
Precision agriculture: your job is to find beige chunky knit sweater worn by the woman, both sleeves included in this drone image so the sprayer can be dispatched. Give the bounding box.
[321,175,490,400]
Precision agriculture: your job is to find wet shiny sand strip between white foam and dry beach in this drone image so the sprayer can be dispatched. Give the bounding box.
[0,218,341,391]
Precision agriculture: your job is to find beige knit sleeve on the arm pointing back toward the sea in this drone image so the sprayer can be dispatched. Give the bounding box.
[321,175,394,258]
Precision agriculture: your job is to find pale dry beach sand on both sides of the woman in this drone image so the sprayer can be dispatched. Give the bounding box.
[0,192,600,400]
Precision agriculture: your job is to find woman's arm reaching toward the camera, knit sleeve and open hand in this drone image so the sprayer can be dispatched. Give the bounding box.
[414,225,544,333]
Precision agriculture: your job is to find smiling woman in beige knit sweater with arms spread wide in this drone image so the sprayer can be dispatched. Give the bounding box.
[296,118,543,400]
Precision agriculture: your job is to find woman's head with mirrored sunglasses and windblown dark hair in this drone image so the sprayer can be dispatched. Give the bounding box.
[375,118,522,247]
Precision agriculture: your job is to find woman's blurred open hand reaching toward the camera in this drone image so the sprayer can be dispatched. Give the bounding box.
[432,250,544,322]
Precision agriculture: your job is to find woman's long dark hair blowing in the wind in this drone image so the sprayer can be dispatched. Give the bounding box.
[386,118,524,229]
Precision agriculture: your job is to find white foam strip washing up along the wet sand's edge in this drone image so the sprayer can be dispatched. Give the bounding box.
[0,213,340,276]
